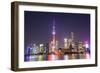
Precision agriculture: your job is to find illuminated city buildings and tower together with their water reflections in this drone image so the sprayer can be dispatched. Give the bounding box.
[24,20,90,62]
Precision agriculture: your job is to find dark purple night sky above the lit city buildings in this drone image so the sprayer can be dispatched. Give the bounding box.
[24,11,90,46]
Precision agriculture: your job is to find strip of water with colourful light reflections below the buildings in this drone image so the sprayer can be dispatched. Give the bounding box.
[24,53,90,62]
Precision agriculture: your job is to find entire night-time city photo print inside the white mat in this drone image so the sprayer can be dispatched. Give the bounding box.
[24,11,90,61]
